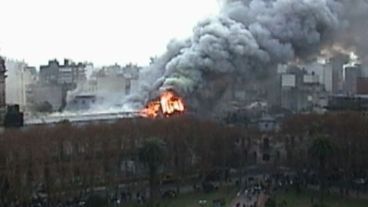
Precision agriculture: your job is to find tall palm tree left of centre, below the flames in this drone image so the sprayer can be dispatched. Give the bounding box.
[138,138,166,204]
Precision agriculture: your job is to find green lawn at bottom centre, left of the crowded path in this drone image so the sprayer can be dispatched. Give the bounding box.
[129,187,236,207]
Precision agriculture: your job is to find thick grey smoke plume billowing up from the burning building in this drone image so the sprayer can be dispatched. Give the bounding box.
[125,0,368,111]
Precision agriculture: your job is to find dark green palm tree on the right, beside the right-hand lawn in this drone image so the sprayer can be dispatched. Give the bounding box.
[309,135,334,206]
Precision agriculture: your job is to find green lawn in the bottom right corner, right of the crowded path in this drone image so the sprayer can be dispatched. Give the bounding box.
[276,192,368,207]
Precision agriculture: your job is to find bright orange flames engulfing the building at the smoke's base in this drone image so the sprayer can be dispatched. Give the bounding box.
[141,91,185,118]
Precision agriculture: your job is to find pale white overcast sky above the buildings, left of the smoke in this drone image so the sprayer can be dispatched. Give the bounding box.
[0,0,218,66]
